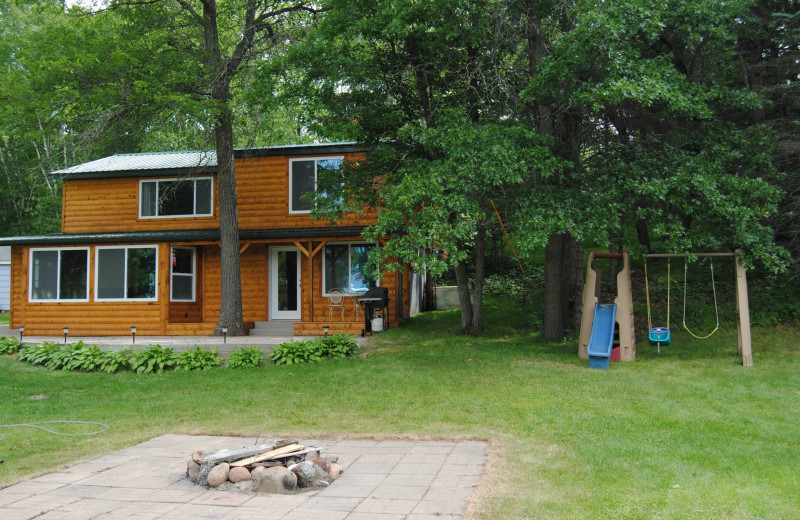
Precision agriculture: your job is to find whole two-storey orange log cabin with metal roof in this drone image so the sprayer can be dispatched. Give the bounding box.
[0,143,412,337]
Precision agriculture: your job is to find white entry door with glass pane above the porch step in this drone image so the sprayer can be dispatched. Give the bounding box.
[269,246,300,320]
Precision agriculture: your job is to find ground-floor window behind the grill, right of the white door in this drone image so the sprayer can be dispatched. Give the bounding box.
[322,242,379,296]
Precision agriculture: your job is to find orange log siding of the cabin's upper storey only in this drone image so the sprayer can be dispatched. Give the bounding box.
[61,154,375,233]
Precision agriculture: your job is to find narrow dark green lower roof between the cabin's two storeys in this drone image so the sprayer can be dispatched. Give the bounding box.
[0,226,366,246]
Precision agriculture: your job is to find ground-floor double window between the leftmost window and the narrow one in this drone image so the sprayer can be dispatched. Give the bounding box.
[94,245,158,301]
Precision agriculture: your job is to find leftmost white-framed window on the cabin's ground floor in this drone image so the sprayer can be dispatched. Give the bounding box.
[28,247,89,302]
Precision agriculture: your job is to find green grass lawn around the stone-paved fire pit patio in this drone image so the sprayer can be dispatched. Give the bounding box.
[0,300,800,519]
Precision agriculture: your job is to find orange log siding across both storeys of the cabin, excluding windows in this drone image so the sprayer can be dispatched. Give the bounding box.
[10,154,408,339]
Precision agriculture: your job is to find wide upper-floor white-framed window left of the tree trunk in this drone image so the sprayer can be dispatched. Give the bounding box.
[139,177,214,218]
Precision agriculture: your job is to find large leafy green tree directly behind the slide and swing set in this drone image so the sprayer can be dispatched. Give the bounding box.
[513,0,783,340]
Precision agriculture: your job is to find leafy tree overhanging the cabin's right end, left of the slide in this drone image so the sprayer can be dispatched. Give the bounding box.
[282,0,558,334]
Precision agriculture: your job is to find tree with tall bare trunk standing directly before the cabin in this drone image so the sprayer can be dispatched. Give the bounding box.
[104,0,322,335]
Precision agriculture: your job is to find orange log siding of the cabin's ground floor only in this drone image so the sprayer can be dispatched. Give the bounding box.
[10,237,410,338]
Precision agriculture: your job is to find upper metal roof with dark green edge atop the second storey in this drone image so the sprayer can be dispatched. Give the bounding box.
[52,142,366,179]
